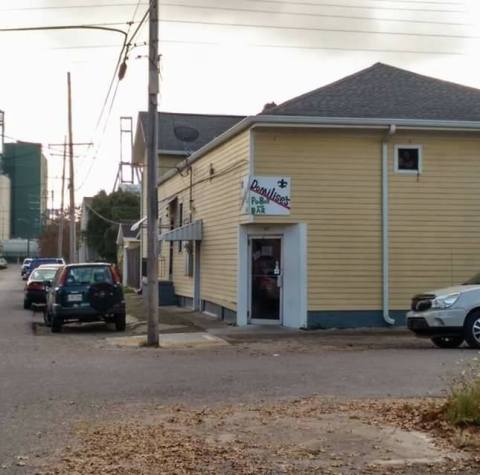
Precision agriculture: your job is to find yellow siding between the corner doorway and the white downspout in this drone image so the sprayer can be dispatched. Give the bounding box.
[255,129,381,310]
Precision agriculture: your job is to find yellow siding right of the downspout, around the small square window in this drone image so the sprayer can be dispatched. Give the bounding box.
[389,132,480,308]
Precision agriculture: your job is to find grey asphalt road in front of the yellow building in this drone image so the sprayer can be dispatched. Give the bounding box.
[0,266,478,473]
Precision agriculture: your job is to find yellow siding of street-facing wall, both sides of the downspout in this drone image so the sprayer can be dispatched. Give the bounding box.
[255,130,480,310]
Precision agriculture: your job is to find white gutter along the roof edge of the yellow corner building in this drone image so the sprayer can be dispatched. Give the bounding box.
[158,115,480,184]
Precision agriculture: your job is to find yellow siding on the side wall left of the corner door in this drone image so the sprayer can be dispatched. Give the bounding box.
[159,132,249,310]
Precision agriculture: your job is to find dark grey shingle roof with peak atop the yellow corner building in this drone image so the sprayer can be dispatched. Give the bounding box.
[262,63,480,121]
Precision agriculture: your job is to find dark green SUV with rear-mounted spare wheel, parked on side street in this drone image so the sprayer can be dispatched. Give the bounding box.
[44,263,125,332]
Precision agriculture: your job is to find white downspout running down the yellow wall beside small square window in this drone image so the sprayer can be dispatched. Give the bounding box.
[382,124,396,325]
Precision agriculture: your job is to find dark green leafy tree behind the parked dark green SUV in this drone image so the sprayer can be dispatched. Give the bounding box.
[87,190,140,262]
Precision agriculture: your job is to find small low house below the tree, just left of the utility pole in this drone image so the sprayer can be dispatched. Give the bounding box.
[117,224,141,289]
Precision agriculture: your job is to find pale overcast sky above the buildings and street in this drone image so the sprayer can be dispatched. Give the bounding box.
[0,0,480,210]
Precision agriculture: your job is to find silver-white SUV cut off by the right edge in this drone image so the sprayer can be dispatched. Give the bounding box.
[407,273,480,348]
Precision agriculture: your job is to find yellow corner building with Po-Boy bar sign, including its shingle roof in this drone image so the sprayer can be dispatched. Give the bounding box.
[158,63,480,328]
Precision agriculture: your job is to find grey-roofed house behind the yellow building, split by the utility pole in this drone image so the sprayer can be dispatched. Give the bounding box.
[133,112,248,286]
